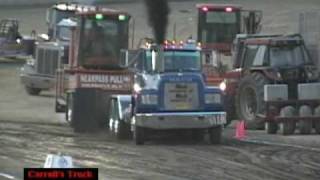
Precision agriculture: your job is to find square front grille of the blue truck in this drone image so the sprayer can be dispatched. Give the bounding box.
[164,83,199,110]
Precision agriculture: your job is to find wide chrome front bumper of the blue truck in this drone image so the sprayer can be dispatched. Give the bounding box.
[133,112,226,130]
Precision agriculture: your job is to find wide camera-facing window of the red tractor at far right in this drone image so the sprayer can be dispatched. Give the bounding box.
[270,45,312,67]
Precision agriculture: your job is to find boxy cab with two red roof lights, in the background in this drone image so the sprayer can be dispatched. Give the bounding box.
[197,4,241,51]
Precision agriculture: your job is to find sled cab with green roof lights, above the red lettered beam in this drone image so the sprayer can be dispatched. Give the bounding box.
[71,8,130,69]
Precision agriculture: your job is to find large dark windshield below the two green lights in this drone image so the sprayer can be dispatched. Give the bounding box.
[80,19,128,67]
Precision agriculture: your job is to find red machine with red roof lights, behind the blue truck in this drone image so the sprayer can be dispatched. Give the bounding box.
[197,4,262,85]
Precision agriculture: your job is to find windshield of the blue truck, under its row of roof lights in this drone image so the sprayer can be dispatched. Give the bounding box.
[164,51,201,72]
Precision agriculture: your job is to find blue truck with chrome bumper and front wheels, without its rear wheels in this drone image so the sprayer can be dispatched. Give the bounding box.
[131,41,226,144]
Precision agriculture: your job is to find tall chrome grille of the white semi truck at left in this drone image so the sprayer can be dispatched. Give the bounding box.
[36,48,59,75]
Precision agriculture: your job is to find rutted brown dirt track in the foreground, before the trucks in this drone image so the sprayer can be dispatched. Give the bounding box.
[0,111,320,180]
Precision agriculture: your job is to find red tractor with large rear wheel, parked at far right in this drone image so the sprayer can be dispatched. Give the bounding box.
[225,34,320,135]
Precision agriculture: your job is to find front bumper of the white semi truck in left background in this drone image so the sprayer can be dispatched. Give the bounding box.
[20,65,55,90]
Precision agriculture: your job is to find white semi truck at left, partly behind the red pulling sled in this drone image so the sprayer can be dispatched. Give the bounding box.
[20,3,82,95]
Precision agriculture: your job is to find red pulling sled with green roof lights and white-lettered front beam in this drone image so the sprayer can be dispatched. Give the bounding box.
[56,7,133,132]
